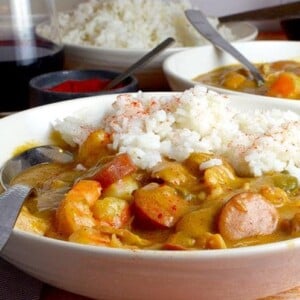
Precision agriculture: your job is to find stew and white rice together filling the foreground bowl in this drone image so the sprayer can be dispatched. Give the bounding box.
[9,86,300,250]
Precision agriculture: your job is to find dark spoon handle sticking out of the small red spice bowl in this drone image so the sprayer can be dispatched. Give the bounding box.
[105,37,175,90]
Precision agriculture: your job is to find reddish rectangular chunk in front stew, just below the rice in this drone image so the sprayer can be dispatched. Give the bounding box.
[92,153,137,188]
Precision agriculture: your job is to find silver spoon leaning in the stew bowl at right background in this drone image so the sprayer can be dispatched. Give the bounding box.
[185,9,265,86]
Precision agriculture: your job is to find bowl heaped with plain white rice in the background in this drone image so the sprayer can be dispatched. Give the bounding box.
[37,0,258,90]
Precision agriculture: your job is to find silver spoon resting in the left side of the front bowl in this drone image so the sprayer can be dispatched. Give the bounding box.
[0,145,73,251]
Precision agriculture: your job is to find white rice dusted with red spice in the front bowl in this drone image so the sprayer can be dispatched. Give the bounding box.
[55,86,300,180]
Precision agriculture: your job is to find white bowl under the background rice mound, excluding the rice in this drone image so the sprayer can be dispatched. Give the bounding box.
[65,22,258,90]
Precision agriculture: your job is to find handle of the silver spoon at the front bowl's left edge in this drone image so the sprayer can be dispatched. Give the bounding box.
[0,184,32,252]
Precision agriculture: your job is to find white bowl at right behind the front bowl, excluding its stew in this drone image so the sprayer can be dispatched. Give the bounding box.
[163,41,300,95]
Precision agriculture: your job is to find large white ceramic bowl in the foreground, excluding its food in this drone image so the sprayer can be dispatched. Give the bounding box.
[0,95,300,300]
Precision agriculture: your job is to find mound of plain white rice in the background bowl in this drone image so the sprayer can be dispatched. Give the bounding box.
[38,0,235,49]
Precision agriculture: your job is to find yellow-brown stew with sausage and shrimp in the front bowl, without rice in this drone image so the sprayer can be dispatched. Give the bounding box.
[13,130,300,250]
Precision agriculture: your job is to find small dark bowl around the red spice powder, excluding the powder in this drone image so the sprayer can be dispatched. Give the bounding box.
[29,70,138,107]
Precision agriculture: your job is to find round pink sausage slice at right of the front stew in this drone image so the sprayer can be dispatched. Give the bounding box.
[218,192,279,240]
